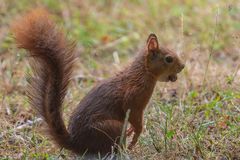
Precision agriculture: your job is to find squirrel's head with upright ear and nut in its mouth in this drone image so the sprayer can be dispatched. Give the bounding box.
[144,34,184,82]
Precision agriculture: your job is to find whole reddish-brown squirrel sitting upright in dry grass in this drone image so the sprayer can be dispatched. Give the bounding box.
[13,9,184,154]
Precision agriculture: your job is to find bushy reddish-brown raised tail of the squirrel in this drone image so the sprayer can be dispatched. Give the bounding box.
[13,9,76,149]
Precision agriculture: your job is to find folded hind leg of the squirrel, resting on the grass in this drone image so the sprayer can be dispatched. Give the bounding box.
[69,120,123,155]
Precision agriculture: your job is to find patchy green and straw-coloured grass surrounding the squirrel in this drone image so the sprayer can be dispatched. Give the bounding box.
[0,0,240,159]
